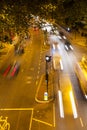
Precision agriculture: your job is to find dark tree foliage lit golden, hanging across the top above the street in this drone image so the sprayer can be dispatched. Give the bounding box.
[0,0,87,41]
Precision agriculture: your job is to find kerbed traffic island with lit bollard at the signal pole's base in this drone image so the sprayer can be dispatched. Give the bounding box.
[35,74,54,103]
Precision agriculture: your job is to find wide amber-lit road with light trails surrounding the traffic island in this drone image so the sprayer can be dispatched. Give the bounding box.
[0,29,87,130]
